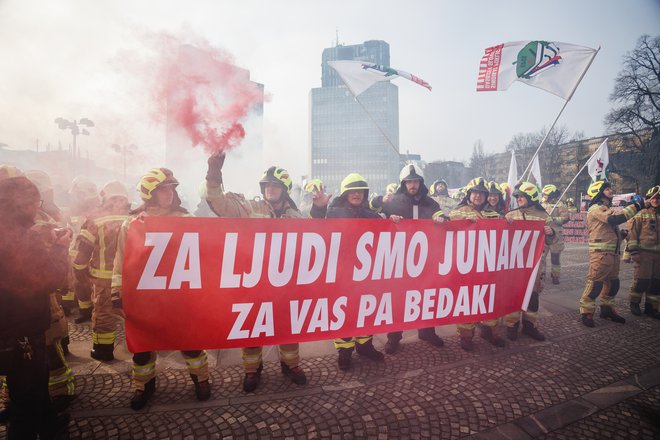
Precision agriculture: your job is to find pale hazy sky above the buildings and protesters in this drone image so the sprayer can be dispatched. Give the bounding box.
[0,0,660,191]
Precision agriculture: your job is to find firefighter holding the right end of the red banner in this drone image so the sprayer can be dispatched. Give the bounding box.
[504,182,558,341]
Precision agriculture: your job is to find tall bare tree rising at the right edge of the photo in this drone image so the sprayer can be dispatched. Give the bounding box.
[605,35,660,187]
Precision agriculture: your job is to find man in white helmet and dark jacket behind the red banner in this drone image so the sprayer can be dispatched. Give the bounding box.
[371,164,446,354]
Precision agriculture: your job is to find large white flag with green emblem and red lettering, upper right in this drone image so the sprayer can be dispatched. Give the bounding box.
[477,41,598,101]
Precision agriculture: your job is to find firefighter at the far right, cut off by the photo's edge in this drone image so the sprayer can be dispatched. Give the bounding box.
[626,185,660,319]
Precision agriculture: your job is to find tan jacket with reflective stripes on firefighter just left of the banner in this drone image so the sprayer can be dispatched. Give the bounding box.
[73,209,128,297]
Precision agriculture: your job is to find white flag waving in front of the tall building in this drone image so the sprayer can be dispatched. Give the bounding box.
[328,60,431,96]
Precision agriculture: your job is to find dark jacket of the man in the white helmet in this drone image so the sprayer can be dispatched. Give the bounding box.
[371,184,445,219]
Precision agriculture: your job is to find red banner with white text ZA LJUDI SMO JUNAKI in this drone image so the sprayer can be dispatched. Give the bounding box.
[122,217,544,353]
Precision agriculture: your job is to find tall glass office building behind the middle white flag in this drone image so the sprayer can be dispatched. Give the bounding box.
[309,40,400,194]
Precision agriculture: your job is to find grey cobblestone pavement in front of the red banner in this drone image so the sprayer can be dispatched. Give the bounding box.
[0,245,660,439]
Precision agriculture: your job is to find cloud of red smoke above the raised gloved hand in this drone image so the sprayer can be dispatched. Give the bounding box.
[152,35,264,153]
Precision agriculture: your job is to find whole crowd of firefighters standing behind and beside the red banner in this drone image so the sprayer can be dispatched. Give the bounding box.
[0,159,660,438]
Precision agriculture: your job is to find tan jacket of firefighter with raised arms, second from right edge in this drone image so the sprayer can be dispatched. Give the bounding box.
[587,201,637,254]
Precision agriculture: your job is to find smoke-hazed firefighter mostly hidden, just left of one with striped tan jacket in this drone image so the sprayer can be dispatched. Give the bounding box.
[62,176,100,324]
